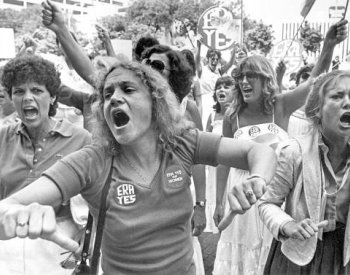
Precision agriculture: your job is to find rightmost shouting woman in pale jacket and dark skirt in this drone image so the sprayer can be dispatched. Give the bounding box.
[259,71,350,274]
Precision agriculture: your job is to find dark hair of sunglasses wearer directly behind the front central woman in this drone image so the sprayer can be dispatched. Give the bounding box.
[142,45,192,102]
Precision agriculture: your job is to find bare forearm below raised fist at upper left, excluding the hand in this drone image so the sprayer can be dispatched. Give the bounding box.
[56,25,95,85]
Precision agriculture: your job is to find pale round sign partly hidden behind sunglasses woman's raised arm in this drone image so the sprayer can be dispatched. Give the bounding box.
[269,39,303,75]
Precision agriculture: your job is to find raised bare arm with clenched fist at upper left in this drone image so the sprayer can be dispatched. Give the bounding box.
[41,0,96,85]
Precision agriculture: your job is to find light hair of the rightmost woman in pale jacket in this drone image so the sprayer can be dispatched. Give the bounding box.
[305,70,350,127]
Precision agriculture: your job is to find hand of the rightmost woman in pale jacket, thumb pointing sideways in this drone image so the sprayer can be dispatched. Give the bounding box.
[281,219,328,241]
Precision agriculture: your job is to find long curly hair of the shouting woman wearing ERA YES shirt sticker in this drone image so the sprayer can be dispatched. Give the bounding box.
[93,62,193,154]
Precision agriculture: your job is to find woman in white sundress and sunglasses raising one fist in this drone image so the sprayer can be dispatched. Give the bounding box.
[214,20,347,275]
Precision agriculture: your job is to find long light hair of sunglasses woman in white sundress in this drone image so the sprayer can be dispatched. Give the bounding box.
[227,55,278,119]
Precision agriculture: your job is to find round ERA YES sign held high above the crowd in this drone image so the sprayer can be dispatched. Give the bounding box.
[197,6,242,51]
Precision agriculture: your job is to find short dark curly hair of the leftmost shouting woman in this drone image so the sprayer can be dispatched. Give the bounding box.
[1,55,61,116]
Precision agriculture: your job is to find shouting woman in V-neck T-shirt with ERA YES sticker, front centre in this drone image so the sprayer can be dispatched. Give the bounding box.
[0,63,275,275]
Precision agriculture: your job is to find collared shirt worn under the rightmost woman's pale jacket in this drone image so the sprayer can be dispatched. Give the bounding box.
[318,135,350,232]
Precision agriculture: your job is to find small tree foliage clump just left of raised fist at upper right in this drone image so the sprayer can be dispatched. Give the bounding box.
[299,21,323,53]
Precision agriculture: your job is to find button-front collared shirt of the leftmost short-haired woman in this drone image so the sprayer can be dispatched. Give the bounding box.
[0,120,91,199]
